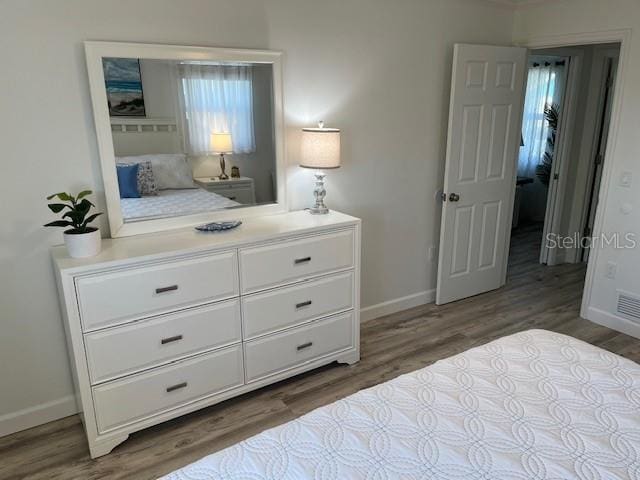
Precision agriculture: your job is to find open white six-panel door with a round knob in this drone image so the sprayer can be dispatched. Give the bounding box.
[436,44,527,304]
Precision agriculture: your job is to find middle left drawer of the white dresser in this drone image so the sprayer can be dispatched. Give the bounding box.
[85,299,242,383]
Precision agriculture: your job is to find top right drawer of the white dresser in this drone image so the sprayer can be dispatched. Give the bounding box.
[240,230,354,292]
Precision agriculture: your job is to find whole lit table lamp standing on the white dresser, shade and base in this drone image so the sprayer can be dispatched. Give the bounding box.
[300,122,340,215]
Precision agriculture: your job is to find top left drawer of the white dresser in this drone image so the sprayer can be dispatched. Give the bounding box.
[76,252,238,331]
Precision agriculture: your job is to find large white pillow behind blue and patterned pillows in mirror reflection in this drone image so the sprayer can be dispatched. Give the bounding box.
[116,153,196,190]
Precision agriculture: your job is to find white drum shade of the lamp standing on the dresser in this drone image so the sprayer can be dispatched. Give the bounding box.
[300,127,340,169]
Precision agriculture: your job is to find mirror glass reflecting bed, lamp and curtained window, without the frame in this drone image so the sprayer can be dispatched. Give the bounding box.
[102,58,277,222]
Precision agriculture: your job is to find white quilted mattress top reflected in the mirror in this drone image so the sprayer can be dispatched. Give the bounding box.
[120,188,240,222]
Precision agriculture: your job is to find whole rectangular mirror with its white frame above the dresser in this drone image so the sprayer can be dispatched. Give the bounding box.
[85,42,286,237]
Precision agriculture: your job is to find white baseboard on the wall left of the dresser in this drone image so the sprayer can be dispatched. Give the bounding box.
[0,395,78,437]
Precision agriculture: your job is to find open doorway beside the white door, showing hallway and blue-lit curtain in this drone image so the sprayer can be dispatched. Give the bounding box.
[510,44,620,276]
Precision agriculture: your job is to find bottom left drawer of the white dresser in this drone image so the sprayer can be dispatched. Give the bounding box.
[93,345,244,433]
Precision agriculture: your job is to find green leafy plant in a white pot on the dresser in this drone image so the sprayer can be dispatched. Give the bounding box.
[45,190,102,258]
